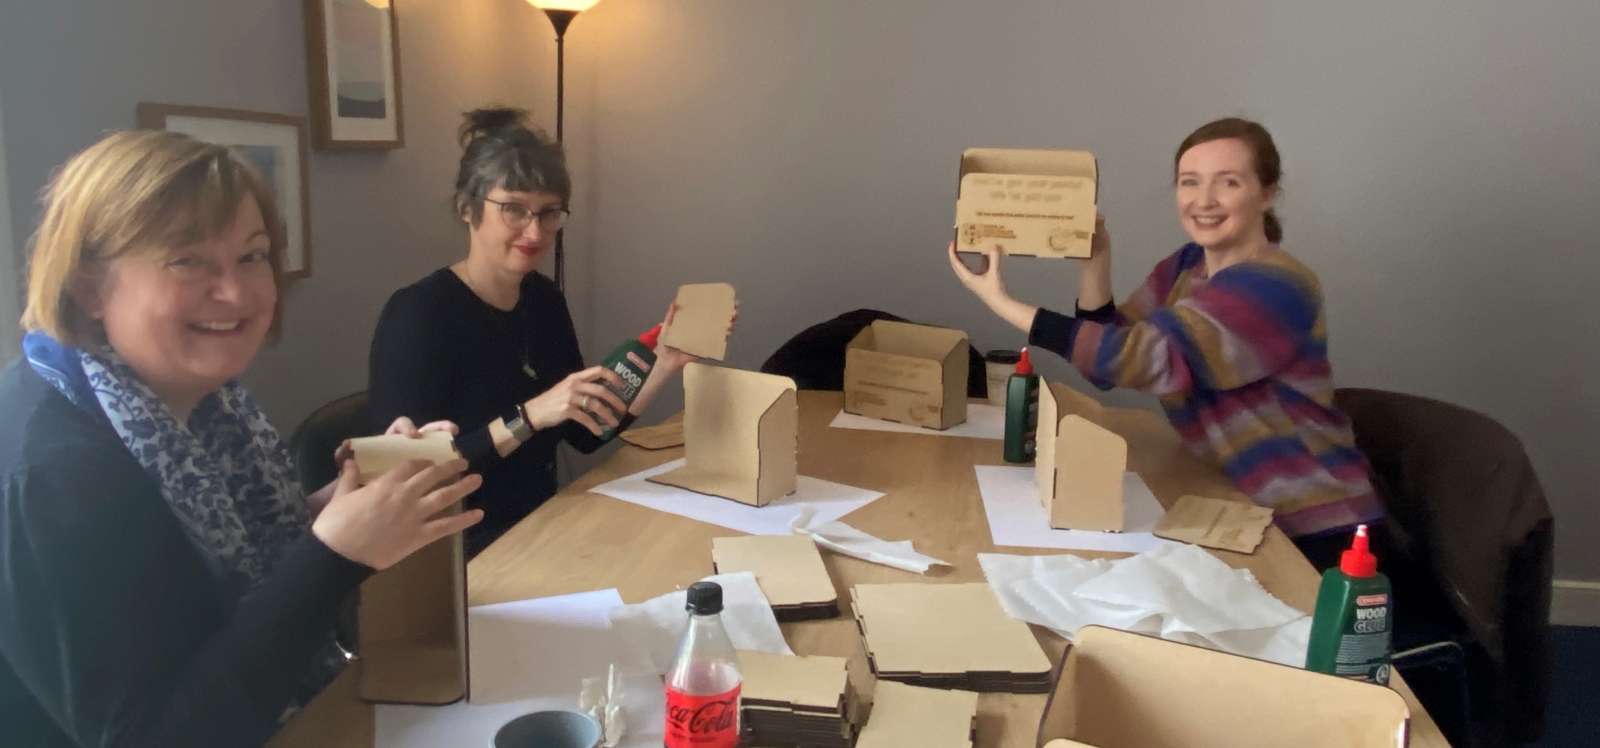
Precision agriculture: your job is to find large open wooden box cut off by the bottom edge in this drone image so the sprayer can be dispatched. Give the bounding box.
[1037,627,1410,748]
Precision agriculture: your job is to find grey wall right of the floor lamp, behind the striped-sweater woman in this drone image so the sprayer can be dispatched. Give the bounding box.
[568,0,1600,579]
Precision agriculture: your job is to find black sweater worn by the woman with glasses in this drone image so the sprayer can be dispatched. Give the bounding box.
[368,267,624,556]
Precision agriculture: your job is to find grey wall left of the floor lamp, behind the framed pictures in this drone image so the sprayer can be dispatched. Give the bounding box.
[0,0,555,432]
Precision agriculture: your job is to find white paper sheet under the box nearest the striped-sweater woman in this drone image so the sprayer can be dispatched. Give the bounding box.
[973,465,1181,553]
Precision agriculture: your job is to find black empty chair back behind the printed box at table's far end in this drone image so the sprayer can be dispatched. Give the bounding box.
[762,308,989,398]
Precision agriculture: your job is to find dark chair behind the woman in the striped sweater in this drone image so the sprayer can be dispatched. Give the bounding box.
[1334,390,1554,748]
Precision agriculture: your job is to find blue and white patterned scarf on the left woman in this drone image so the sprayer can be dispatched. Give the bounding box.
[22,332,344,716]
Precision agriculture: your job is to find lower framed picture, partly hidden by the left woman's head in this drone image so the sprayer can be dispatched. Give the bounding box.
[139,104,310,280]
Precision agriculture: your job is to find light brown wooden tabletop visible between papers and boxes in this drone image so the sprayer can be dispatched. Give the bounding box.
[272,392,1448,748]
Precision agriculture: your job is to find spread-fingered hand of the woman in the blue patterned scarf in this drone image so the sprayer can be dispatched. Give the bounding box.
[310,459,483,571]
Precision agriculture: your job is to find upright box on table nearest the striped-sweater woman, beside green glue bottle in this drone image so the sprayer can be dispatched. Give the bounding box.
[1034,382,1128,532]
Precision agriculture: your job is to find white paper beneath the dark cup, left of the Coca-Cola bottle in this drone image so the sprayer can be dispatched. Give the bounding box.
[373,590,666,748]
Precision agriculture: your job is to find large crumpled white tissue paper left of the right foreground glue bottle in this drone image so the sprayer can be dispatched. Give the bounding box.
[978,545,1310,668]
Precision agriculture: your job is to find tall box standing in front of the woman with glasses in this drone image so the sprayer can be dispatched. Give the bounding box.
[648,363,800,507]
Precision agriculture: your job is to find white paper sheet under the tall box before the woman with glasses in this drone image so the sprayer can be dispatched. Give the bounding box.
[590,460,883,535]
